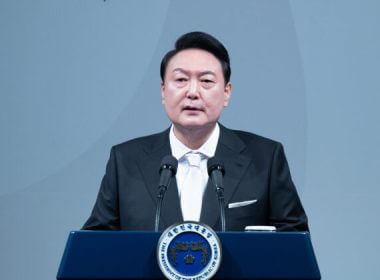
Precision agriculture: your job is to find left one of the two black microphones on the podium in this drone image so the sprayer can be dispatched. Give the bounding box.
[154,155,178,232]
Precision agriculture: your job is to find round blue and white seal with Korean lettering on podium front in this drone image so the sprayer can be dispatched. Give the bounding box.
[157,222,222,280]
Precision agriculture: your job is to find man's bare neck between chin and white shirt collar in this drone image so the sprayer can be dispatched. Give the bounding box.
[173,123,216,150]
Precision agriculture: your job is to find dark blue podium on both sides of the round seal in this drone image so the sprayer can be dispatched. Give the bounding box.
[57,231,321,280]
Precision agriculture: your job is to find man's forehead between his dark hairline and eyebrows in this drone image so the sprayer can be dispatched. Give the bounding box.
[166,49,222,75]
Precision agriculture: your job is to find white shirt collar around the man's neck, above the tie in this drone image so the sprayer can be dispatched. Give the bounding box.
[169,123,220,160]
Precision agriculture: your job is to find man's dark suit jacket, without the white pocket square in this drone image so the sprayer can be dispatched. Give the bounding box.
[83,126,308,231]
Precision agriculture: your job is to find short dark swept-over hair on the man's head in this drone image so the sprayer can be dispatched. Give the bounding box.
[160,31,231,84]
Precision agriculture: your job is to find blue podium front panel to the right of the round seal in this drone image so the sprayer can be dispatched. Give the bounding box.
[217,232,321,279]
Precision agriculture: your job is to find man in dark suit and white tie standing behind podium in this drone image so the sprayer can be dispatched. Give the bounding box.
[83,32,308,231]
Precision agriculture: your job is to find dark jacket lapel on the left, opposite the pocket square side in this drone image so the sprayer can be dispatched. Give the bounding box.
[138,129,183,229]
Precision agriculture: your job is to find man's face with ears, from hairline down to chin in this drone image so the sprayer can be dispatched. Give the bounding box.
[161,49,231,129]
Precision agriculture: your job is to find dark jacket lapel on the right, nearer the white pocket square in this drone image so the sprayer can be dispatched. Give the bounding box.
[200,125,251,228]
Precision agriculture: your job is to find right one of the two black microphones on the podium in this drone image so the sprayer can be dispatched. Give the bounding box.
[207,157,226,232]
